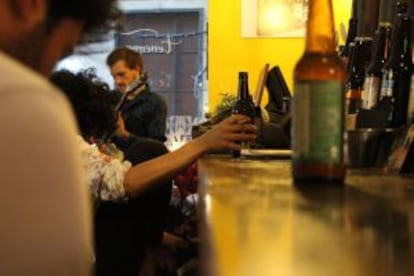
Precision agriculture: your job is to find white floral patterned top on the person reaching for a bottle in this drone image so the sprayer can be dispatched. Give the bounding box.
[78,136,131,201]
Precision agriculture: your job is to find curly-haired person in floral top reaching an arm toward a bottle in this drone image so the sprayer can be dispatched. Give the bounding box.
[51,70,256,275]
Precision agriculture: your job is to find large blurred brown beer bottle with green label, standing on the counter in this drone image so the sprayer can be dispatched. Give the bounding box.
[292,0,346,183]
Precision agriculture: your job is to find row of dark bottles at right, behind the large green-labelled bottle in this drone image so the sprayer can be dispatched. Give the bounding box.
[339,0,414,168]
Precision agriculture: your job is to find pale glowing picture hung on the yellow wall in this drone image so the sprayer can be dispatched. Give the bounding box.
[241,0,308,38]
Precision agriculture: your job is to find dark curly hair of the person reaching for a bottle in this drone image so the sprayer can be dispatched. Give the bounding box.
[50,69,116,140]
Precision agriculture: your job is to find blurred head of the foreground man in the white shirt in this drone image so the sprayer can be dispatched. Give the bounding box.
[0,0,120,75]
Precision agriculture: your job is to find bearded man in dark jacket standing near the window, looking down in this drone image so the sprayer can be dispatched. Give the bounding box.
[106,47,167,142]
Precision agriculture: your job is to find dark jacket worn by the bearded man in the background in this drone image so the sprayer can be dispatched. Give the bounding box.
[121,86,167,142]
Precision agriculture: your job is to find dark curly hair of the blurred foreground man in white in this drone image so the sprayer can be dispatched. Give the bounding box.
[47,0,121,32]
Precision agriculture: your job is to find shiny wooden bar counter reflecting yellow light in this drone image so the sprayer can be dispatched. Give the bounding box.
[198,155,414,276]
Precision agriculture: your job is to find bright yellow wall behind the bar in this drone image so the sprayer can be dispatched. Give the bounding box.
[208,0,352,111]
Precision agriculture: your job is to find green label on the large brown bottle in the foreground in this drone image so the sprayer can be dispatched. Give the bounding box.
[292,81,344,164]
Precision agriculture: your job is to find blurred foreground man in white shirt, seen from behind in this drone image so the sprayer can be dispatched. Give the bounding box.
[0,0,117,276]
